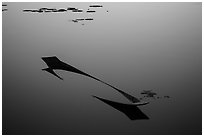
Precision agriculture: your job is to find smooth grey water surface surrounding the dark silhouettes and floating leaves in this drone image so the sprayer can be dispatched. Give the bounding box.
[2,3,202,134]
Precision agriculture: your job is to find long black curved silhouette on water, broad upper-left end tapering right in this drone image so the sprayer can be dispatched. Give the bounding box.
[42,56,140,103]
